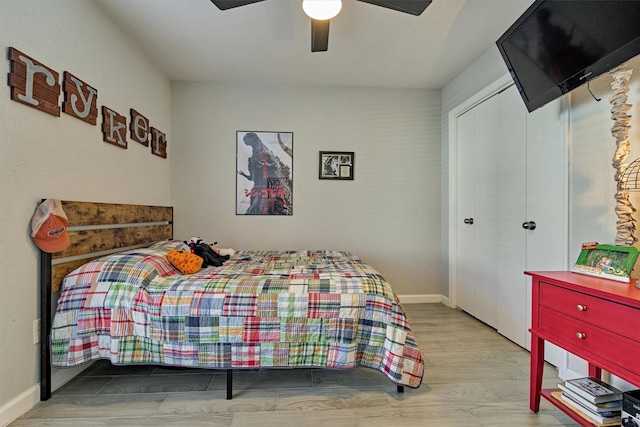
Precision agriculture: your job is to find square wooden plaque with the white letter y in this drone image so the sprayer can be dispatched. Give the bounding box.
[62,71,98,126]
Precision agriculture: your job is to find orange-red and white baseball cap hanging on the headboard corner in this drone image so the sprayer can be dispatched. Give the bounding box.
[31,199,71,253]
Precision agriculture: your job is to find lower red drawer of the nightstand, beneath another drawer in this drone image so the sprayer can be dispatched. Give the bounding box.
[540,307,640,369]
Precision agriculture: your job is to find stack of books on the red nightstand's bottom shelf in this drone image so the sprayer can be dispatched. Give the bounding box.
[558,377,622,426]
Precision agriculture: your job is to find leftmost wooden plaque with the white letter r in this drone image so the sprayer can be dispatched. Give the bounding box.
[9,47,60,117]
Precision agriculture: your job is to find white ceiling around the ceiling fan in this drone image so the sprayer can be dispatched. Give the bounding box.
[95,0,533,89]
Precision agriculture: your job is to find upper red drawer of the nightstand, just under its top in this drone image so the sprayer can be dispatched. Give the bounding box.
[540,283,640,341]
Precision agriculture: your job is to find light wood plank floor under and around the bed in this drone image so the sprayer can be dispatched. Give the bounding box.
[10,304,577,427]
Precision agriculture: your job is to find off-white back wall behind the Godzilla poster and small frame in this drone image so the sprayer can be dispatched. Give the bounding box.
[171,82,440,299]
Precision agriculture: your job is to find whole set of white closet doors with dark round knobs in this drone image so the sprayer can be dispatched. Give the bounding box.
[455,86,567,354]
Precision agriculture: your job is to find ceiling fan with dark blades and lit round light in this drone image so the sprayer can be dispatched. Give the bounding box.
[211,0,432,52]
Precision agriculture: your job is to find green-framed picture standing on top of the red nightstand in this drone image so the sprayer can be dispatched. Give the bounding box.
[573,242,638,282]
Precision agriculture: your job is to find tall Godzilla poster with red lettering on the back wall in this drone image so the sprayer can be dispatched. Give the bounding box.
[236,131,293,215]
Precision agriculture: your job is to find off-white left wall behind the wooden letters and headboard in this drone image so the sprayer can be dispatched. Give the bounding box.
[0,0,171,425]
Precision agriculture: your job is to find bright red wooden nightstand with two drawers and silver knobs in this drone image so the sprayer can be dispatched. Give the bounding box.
[525,271,640,426]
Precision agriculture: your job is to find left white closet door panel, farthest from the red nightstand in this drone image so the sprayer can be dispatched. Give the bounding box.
[456,93,500,327]
